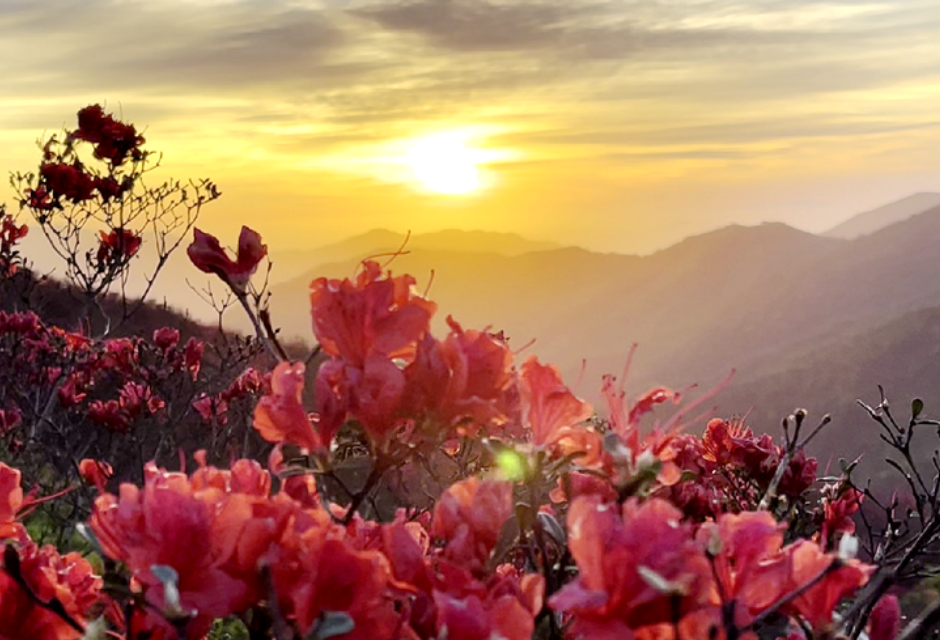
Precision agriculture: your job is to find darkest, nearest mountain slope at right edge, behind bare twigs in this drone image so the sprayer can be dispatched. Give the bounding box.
[717,307,940,485]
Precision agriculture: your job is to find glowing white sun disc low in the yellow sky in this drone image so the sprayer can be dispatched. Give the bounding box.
[405,133,481,195]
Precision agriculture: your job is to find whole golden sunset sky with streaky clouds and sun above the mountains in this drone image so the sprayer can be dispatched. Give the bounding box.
[0,0,940,252]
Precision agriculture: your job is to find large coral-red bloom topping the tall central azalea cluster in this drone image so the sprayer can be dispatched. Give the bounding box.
[310,262,437,368]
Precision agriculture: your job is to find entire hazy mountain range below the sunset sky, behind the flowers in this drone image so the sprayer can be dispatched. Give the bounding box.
[248,194,940,480]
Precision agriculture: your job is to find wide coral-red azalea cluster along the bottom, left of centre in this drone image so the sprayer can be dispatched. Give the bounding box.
[91,455,542,640]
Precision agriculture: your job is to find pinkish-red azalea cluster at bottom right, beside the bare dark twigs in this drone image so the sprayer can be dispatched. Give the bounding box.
[549,497,874,640]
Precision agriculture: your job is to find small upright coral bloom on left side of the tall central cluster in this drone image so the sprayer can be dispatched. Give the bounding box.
[254,362,324,451]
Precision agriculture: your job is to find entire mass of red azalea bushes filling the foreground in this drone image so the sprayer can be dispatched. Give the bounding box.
[0,105,924,640]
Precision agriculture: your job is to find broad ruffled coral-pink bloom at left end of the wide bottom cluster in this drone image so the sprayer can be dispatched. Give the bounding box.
[90,463,276,638]
